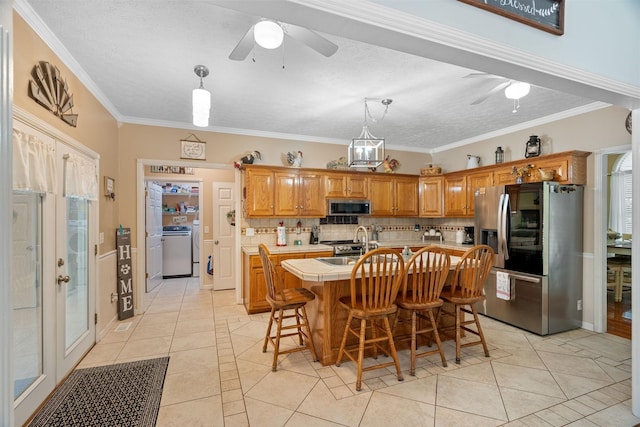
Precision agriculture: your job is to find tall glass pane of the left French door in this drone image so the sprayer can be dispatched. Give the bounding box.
[11,191,43,398]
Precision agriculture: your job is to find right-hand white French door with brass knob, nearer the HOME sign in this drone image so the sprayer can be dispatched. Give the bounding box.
[55,142,96,381]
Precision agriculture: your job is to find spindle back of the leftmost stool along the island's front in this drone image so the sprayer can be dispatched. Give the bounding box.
[351,248,404,310]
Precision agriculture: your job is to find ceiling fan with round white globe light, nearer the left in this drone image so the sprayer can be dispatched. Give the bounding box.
[229,19,338,61]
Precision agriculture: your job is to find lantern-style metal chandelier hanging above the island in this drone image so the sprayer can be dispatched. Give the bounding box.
[348,98,393,168]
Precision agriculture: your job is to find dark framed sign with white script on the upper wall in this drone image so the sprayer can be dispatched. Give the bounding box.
[459,0,564,36]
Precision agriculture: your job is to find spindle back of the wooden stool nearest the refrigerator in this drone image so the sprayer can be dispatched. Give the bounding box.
[451,245,494,298]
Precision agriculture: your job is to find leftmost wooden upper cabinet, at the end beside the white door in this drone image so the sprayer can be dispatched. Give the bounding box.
[244,168,274,218]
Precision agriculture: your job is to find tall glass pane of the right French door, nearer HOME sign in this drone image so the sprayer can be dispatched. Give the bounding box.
[64,197,89,349]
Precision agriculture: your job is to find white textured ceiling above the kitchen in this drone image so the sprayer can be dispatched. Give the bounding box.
[22,0,593,151]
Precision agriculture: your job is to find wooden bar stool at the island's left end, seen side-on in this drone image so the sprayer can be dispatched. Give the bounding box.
[258,244,318,371]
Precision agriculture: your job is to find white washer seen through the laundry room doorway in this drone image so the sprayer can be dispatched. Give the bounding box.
[162,225,193,278]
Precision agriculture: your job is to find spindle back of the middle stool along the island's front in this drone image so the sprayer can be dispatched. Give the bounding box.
[402,246,451,304]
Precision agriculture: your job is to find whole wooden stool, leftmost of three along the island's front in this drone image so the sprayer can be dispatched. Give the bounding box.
[336,248,404,391]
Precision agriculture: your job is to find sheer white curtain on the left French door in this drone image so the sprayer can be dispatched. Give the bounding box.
[13,129,56,193]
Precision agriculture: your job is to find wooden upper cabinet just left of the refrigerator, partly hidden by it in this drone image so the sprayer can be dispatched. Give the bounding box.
[444,171,493,217]
